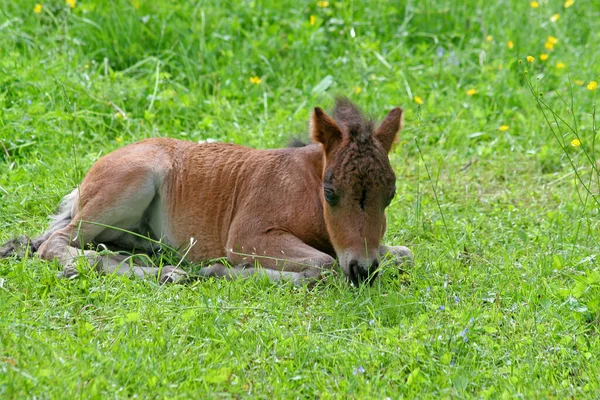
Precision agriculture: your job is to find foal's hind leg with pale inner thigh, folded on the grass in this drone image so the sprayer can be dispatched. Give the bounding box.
[38,154,187,282]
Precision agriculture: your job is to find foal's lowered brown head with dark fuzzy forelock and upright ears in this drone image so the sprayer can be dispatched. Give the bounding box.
[311,99,402,284]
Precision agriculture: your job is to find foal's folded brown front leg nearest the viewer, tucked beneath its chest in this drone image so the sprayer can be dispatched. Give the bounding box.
[200,233,335,286]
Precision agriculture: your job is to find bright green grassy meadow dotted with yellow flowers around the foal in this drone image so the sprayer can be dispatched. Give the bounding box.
[0,0,600,399]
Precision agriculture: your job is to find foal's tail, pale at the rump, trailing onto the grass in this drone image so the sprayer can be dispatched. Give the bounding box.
[0,189,77,258]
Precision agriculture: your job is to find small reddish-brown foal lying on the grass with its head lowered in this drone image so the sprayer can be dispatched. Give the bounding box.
[0,99,412,285]
